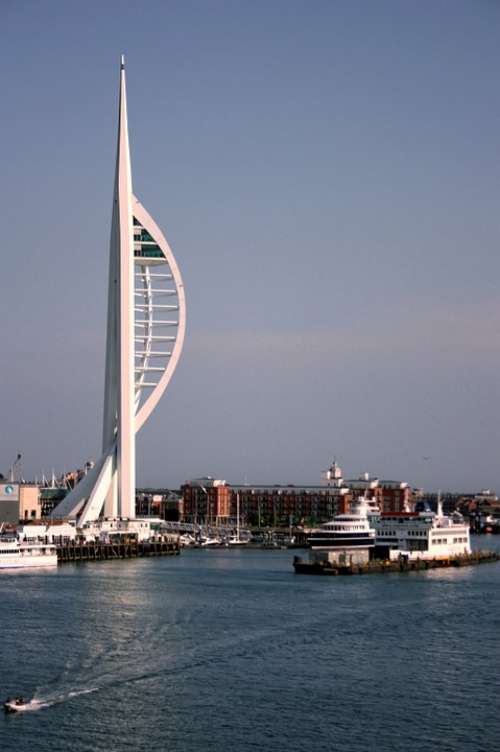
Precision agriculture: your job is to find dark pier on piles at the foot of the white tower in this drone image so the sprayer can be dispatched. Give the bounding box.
[57,540,180,563]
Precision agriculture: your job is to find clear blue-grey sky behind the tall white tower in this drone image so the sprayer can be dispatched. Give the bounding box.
[0,0,500,491]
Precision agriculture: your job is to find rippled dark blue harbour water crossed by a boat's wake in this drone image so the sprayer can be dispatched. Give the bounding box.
[0,538,500,752]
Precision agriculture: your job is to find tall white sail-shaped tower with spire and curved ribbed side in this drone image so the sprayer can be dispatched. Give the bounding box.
[52,57,186,525]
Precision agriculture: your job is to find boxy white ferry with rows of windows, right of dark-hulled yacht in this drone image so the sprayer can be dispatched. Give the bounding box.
[370,503,471,560]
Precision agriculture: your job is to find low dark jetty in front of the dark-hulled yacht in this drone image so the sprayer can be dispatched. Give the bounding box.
[293,551,500,577]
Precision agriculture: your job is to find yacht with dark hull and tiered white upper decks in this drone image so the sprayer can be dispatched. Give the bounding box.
[308,497,376,551]
